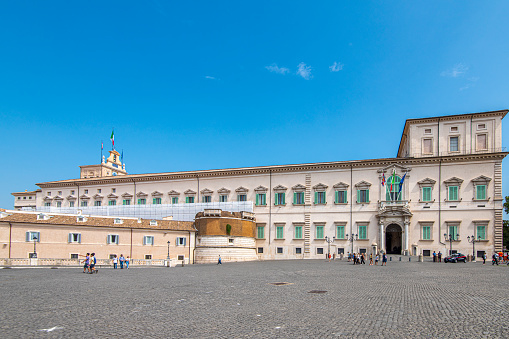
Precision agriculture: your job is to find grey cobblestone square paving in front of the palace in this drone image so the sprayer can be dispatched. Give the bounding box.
[0,260,509,338]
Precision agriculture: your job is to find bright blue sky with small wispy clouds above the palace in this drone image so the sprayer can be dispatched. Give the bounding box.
[0,1,509,212]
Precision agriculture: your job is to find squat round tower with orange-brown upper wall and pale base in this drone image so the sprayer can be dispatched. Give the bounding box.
[195,209,258,264]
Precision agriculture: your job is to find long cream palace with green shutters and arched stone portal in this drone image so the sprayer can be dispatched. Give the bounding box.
[9,110,508,260]
